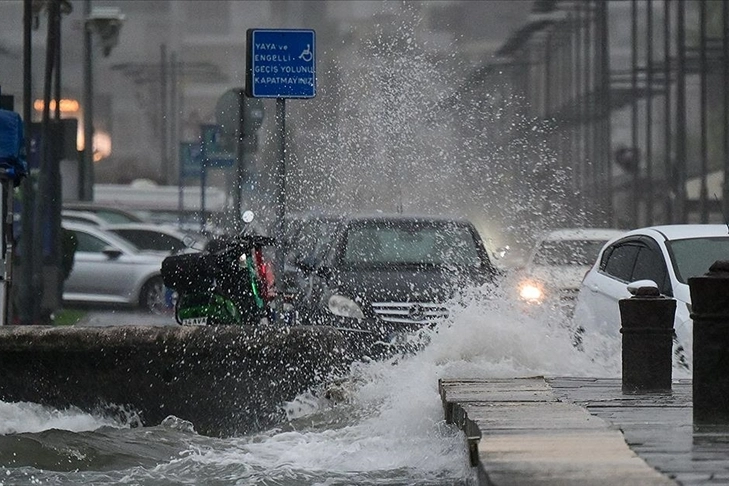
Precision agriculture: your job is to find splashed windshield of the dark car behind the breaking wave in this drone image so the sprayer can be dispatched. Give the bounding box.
[343,222,481,267]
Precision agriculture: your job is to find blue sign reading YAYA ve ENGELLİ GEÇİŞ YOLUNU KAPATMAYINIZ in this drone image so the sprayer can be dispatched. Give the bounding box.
[246,29,316,98]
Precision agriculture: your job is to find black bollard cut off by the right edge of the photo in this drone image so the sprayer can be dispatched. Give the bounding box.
[689,261,729,425]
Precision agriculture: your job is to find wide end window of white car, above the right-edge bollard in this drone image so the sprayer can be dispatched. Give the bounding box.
[667,236,729,284]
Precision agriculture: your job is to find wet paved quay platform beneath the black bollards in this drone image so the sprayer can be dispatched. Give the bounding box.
[439,377,729,486]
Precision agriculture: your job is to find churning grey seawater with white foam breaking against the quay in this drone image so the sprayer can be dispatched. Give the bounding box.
[0,292,636,486]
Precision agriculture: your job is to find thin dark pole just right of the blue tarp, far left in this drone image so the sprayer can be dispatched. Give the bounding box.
[17,0,35,325]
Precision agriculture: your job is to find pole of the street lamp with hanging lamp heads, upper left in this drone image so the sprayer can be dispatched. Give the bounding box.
[79,0,94,201]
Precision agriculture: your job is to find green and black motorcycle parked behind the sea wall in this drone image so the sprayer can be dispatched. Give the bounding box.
[161,213,275,326]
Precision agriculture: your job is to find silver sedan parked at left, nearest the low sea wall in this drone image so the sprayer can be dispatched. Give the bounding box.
[62,221,166,312]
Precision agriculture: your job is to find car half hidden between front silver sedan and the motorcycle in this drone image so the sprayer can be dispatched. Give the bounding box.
[104,223,208,253]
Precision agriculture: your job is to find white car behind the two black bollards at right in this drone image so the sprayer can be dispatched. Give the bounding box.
[573,224,729,365]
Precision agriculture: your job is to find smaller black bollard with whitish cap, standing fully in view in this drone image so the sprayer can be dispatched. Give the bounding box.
[618,282,676,393]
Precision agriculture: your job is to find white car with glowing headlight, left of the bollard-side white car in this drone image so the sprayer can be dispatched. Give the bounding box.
[516,228,625,315]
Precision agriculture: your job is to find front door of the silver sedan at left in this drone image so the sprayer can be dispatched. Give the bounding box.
[64,229,141,303]
